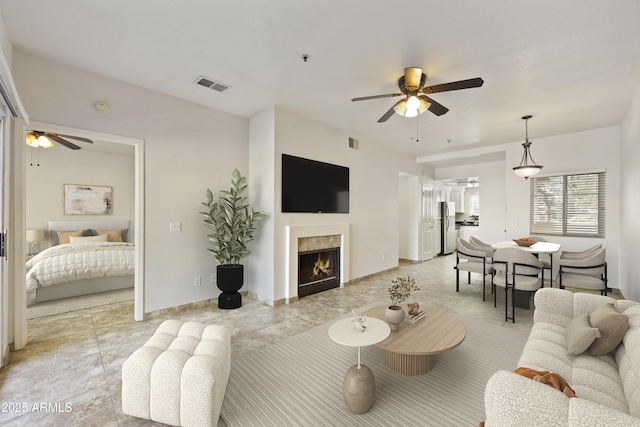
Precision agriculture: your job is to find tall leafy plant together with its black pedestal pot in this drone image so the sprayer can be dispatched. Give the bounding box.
[201,169,266,309]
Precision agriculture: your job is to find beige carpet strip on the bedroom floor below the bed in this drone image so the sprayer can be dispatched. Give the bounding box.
[27,288,133,319]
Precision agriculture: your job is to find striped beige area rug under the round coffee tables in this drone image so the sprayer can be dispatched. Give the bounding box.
[221,310,528,427]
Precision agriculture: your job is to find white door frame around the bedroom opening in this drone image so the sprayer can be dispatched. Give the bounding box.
[14,121,144,350]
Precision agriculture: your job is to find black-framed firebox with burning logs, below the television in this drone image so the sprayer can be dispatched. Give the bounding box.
[298,247,340,297]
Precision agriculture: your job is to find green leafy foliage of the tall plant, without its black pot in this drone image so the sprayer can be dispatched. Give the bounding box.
[200,169,266,265]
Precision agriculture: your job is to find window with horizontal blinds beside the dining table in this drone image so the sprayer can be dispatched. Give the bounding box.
[531,172,606,237]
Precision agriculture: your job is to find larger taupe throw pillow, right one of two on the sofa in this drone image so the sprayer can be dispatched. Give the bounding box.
[589,304,629,356]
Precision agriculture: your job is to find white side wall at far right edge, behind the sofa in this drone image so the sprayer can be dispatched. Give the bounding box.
[620,82,640,301]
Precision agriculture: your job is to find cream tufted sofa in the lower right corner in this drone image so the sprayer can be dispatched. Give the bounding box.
[485,288,640,427]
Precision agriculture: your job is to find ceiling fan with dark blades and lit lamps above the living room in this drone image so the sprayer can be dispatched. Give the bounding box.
[351,67,484,123]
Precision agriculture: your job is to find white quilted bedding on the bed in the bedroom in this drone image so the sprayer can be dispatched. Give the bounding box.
[27,242,135,304]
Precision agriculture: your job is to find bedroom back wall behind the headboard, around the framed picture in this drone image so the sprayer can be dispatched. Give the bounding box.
[26,145,135,249]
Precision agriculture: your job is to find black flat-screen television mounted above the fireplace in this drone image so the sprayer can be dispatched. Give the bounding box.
[282,154,349,213]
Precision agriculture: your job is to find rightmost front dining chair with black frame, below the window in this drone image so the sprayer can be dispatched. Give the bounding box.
[558,248,608,295]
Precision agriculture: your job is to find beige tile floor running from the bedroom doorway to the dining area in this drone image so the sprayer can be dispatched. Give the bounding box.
[0,255,616,426]
